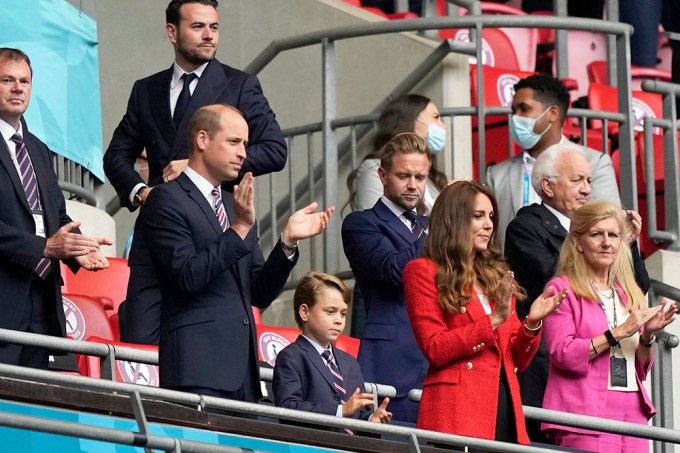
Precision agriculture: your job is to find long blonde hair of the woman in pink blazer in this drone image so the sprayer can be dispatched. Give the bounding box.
[557,200,646,311]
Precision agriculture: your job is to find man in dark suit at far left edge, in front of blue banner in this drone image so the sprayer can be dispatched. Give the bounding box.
[0,48,111,369]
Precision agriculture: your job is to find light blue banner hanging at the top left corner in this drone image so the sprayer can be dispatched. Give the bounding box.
[0,0,104,181]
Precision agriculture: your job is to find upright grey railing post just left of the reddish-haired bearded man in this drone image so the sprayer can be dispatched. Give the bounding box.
[321,38,341,273]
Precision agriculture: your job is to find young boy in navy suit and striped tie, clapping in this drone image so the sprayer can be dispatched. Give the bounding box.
[273,272,392,423]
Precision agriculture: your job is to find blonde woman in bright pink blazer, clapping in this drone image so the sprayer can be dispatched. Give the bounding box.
[541,200,677,453]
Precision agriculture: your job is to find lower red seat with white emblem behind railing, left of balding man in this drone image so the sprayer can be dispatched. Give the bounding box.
[86,337,159,387]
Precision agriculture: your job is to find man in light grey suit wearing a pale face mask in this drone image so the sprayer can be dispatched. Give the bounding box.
[486,74,621,251]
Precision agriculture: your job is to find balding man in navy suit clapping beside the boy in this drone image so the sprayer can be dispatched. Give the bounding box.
[142,105,333,402]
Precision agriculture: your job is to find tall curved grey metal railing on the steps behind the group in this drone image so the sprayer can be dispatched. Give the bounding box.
[245,15,637,273]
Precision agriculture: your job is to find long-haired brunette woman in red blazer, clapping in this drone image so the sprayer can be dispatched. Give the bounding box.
[404,181,565,444]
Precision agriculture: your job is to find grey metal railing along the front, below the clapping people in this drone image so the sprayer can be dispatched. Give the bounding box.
[0,322,680,453]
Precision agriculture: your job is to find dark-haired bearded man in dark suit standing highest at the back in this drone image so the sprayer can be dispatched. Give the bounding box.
[104,0,288,344]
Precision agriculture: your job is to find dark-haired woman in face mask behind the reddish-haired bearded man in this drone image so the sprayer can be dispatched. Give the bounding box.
[343,94,447,215]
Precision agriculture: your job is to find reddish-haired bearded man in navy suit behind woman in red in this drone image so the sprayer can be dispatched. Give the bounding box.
[342,132,432,423]
